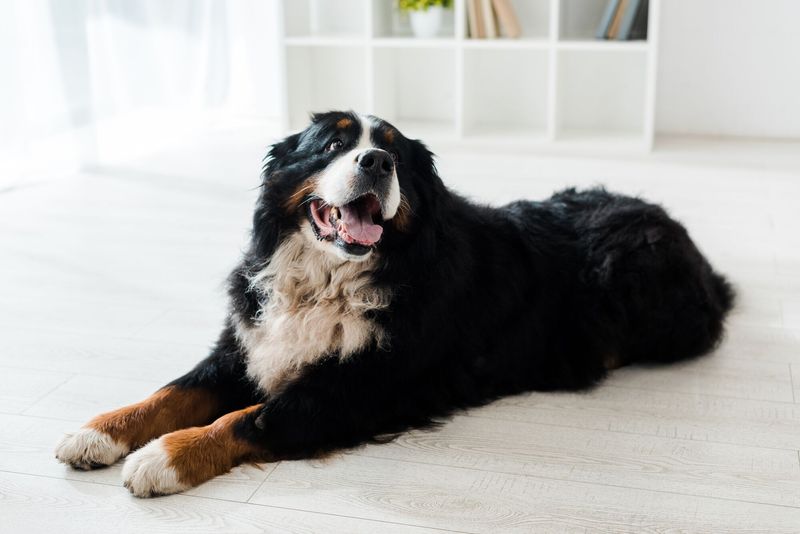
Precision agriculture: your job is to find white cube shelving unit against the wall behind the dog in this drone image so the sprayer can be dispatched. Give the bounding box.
[281,0,660,150]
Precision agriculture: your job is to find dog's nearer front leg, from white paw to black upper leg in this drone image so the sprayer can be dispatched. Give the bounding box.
[122,361,422,497]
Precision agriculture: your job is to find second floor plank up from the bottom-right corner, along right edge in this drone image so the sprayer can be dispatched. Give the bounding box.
[355,417,800,508]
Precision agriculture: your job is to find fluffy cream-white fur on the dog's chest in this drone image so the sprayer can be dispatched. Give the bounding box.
[235,232,390,392]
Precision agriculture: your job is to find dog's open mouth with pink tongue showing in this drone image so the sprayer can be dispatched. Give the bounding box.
[308,193,383,254]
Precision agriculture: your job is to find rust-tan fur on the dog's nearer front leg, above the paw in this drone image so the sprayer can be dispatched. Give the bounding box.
[162,404,266,486]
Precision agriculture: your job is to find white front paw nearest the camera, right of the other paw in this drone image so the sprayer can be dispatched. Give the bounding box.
[122,437,191,497]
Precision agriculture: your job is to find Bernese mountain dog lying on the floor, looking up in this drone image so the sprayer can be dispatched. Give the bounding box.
[56,112,734,497]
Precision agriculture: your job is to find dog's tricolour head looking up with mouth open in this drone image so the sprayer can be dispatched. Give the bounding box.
[254,112,441,261]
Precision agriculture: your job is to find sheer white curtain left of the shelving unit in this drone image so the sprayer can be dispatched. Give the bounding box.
[0,0,280,182]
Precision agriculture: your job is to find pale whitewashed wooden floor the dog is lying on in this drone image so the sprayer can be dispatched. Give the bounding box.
[0,132,800,534]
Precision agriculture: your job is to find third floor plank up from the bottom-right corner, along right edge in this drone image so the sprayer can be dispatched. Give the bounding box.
[468,385,800,450]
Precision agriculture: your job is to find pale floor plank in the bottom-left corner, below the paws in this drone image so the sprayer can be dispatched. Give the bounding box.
[0,473,450,534]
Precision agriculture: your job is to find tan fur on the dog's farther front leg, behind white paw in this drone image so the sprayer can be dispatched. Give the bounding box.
[86,386,218,449]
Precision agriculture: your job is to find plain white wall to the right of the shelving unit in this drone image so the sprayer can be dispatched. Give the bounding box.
[656,0,800,138]
